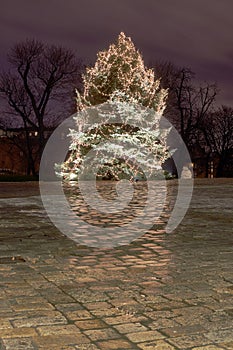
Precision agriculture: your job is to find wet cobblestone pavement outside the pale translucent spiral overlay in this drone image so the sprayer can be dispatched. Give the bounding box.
[0,179,233,350]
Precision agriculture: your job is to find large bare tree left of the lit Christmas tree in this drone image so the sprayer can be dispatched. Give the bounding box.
[0,40,82,174]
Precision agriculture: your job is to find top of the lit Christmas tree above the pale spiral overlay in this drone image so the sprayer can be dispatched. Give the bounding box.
[77,33,167,114]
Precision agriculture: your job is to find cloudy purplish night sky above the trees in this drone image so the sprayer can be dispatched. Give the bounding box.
[0,0,233,106]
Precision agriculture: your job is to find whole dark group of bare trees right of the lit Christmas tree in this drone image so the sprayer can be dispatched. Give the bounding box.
[152,62,233,177]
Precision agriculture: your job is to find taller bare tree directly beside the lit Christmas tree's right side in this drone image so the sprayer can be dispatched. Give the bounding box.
[154,62,217,147]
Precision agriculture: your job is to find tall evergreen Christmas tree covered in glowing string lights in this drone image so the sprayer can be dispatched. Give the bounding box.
[57,33,171,180]
